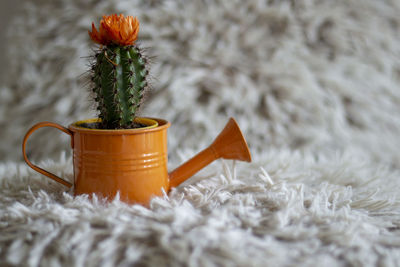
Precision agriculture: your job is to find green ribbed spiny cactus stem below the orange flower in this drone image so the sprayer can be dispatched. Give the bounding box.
[92,45,148,129]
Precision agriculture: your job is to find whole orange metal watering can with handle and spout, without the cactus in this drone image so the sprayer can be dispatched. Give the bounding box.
[22,118,251,204]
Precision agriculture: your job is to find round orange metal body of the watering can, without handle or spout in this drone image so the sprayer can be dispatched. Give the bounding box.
[69,119,170,204]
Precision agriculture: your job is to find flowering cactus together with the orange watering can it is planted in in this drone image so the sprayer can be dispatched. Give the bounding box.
[22,15,251,204]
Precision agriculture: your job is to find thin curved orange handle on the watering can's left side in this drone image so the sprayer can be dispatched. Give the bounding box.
[22,121,73,187]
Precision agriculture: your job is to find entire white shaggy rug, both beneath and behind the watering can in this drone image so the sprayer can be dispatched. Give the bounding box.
[0,0,400,266]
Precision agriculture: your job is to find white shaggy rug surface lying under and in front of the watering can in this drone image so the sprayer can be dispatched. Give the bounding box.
[0,150,400,266]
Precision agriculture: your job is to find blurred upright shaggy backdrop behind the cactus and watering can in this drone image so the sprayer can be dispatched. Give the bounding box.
[0,0,400,172]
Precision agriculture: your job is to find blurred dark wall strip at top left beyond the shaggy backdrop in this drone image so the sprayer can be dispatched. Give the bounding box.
[0,0,22,84]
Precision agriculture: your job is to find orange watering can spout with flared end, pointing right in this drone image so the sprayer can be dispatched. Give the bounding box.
[169,118,251,188]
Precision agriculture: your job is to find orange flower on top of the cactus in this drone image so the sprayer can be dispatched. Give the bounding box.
[89,14,139,46]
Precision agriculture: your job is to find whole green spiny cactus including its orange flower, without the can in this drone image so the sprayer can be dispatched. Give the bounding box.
[89,15,148,129]
